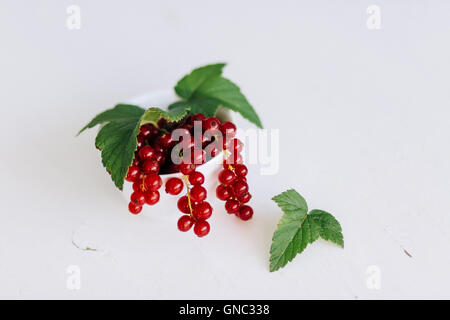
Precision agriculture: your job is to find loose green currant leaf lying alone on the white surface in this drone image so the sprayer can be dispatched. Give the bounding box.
[270,189,344,271]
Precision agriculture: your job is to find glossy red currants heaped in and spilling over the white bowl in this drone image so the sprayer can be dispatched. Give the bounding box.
[125,113,253,237]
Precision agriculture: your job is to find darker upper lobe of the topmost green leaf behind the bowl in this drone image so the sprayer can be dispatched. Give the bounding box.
[175,63,225,99]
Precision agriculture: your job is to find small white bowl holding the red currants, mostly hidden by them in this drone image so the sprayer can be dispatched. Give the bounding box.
[122,90,231,220]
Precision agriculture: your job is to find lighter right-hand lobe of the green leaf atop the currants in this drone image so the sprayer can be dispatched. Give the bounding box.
[192,77,262,128]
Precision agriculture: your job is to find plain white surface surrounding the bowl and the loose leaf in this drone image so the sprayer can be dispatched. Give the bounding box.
[0,0,450,299]
